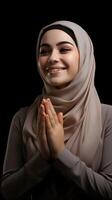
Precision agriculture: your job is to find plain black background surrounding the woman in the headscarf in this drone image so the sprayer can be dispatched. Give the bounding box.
[0,2,112,199]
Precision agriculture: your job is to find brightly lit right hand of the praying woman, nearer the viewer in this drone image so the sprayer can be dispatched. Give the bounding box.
[42,99,65,158]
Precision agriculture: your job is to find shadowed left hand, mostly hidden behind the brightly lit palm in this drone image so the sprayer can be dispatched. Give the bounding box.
[37,101,50,160]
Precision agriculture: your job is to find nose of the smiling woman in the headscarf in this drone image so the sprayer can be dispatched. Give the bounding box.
[48,49,59,63]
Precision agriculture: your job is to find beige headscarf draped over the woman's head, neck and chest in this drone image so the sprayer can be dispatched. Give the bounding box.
[23,21,102,167]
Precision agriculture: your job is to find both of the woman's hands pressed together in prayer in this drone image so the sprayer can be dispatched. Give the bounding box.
[39,99,65,159]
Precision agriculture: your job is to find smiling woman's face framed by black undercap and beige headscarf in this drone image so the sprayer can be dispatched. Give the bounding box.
[37,29,79,88]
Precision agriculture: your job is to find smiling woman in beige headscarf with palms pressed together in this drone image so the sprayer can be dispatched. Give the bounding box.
[2,21,112,200]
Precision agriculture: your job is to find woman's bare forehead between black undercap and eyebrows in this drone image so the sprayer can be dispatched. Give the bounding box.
[40,29,75,44]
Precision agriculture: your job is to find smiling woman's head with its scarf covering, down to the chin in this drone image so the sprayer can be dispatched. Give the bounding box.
[36,21,94,92]
